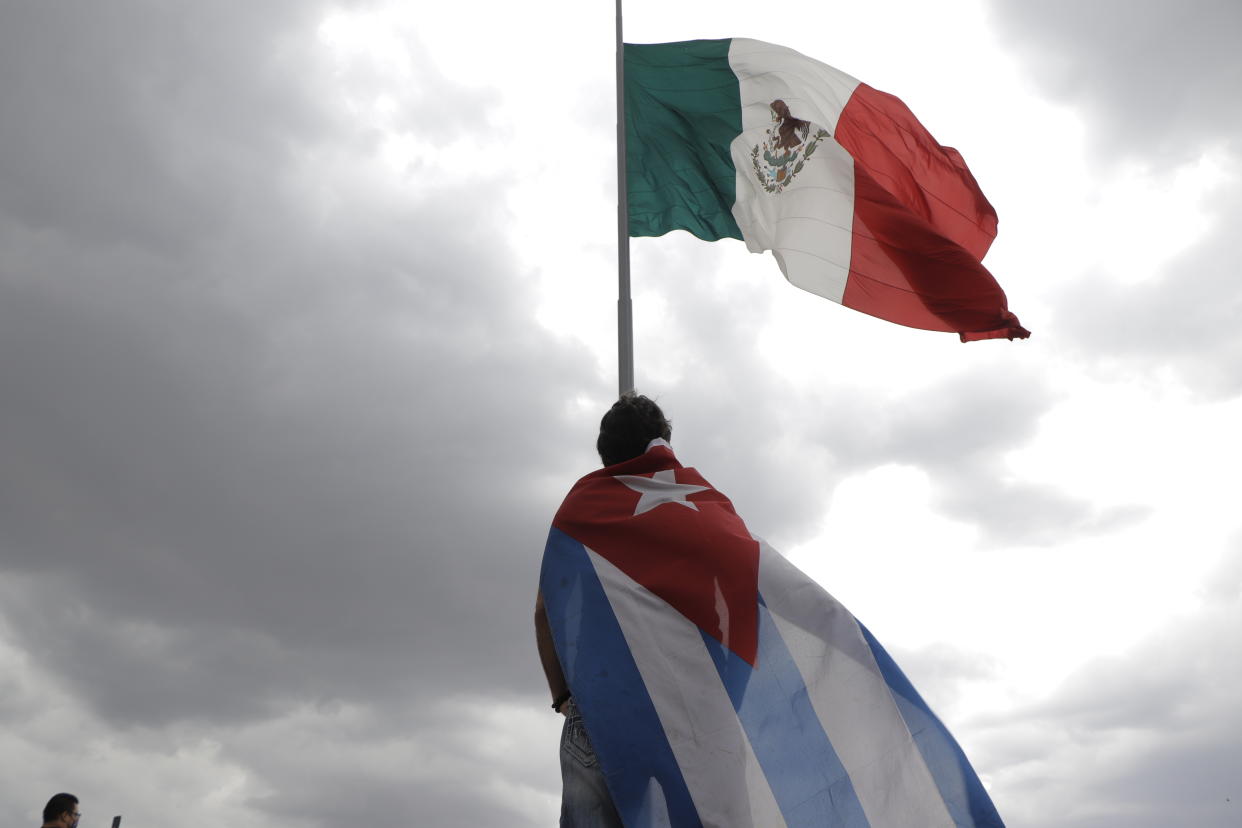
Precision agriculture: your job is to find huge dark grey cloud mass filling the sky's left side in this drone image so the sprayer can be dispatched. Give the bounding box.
[0,4,601,824]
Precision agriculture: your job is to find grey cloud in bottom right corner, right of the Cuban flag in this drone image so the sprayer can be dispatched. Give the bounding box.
[986,544,1242,828]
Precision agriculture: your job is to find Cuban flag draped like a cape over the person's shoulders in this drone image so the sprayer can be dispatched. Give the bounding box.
[540,439,1004,828]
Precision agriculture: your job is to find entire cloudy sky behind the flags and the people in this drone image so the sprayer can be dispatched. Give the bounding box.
[0,0,1242,828]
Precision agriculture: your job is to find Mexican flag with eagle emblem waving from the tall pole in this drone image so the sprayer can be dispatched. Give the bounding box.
[625,37,1030,341]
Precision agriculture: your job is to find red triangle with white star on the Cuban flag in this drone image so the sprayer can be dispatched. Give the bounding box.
[553,441,759,665]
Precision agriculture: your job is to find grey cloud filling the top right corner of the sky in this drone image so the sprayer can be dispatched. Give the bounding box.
[991,0,1242,163]
